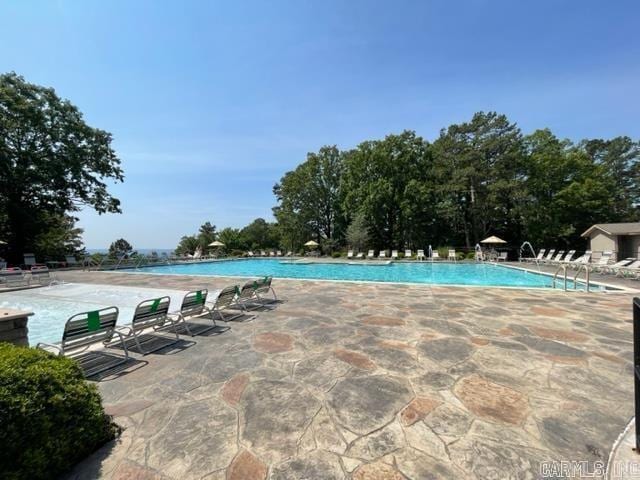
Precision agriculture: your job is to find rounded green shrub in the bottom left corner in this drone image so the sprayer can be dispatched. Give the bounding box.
[0,343,117,479]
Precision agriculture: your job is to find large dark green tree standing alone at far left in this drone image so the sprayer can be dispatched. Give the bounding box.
[0,73,124,263]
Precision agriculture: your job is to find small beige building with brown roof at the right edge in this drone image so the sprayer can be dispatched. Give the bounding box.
[582,222,640,260]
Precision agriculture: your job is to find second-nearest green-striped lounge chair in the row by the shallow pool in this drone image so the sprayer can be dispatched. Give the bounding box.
[118,296,180,355]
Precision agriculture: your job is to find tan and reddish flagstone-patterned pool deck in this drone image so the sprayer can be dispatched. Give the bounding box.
[51,272,633,480]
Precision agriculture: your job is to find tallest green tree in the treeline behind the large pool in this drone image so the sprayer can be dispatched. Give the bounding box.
[433,112,524,248]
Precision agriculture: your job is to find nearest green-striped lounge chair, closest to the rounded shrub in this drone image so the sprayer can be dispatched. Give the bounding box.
[37,307,129,377]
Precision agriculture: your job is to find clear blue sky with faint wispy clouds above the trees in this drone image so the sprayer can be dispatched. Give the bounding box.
[0,0,640,248]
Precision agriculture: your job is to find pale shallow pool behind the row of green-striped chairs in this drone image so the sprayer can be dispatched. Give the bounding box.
[0,283,186,346]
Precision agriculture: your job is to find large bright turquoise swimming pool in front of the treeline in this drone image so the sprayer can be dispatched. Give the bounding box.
[126,259,602,290]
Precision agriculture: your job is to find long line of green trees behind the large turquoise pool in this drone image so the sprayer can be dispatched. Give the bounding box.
[176,112,640,252]
